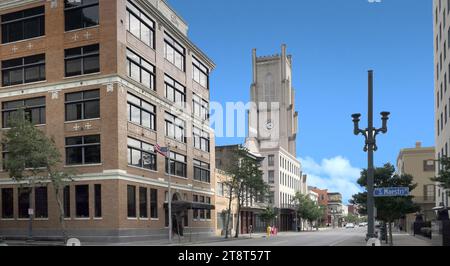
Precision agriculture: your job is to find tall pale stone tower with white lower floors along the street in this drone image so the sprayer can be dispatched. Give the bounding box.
[246,45,307,231]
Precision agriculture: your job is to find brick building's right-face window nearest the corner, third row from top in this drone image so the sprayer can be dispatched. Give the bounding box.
[127,94,156,130]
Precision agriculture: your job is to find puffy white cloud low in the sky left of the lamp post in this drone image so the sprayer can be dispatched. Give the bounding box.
[300,156,362,204]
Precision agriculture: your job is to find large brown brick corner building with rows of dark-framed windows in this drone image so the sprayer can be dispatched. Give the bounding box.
[0,0,216,241]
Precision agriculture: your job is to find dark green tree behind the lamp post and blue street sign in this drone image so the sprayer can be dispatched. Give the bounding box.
[351,163,420,245]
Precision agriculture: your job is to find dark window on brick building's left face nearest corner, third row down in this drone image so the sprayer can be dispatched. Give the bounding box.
[65,90,100,121]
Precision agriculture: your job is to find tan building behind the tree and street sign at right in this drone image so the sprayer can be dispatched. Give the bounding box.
[397,142,436,232]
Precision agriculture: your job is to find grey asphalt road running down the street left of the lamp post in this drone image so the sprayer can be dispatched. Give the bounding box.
[191,227,367,246]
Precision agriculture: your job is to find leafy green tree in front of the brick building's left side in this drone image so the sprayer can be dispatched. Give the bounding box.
[2,110,72,239]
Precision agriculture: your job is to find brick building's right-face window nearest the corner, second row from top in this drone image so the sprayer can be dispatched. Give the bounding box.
[127,49,156,90]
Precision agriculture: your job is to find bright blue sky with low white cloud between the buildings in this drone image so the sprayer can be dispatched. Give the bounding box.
[168,0,434,200]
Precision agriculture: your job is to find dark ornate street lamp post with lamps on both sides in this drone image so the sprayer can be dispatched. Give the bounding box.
[352,70,390,239]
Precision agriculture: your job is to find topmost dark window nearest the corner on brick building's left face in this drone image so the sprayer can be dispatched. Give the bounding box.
[64,0,99,31]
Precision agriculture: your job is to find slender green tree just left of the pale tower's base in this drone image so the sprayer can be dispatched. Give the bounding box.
[225,146,268,238]
